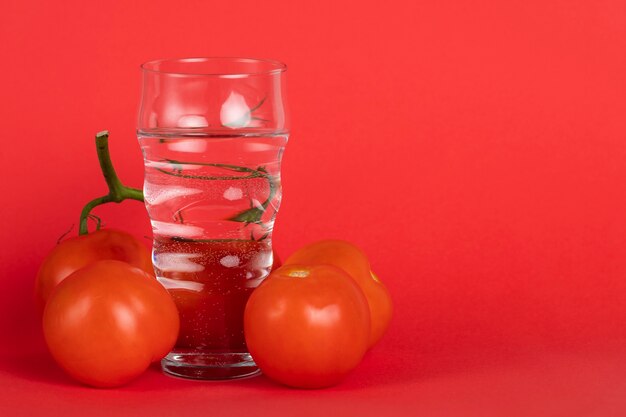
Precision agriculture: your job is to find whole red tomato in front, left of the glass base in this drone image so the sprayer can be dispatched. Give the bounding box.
[43,260,179,387]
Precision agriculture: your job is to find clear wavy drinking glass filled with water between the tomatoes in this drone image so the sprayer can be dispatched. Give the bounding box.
[137,58,289,379]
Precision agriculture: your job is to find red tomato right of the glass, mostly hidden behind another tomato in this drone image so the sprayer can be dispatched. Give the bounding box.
[285,240,393,347]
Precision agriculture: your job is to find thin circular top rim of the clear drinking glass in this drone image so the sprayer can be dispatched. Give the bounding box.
[140,56,287,78]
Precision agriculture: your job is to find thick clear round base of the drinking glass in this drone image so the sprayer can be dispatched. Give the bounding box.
[161,349,261,380]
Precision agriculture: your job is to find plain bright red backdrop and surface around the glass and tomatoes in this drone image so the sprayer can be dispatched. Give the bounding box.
[0,0,626,417]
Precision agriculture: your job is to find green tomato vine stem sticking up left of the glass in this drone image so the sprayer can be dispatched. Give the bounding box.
[78,130,143,235]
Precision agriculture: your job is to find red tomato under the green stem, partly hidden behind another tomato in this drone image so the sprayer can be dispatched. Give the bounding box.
[35,229,154,310]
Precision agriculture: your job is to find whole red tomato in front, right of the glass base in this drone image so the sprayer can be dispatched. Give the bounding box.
[244,265,370,388]
